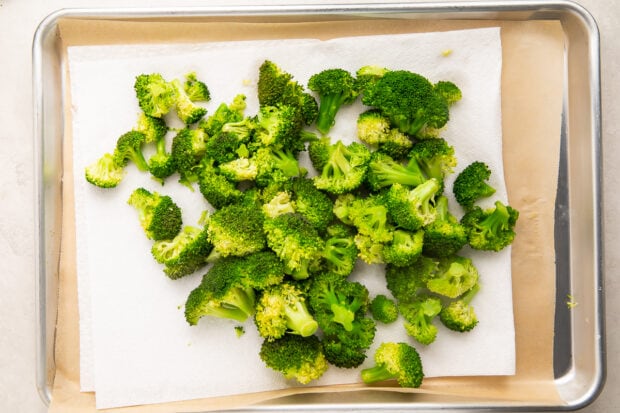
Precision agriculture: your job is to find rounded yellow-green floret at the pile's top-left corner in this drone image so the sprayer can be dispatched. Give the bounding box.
[134,73,177,118]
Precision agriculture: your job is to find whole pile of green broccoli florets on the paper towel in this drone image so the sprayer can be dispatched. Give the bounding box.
[85,60,518,387]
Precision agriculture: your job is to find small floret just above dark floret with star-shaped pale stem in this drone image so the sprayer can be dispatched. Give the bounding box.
[322,223,358,276]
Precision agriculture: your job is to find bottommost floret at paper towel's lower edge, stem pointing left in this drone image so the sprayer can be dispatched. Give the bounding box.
[361,342,424,388]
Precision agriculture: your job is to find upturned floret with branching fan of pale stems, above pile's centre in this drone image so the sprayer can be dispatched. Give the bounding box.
[308,138,370,195]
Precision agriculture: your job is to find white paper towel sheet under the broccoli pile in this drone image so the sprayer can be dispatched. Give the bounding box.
[69,28,515,408]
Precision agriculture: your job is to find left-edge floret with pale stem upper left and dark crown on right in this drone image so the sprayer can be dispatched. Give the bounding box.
[127,188,183,241]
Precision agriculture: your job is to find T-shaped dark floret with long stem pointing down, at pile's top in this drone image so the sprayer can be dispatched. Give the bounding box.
[308,69,359,135]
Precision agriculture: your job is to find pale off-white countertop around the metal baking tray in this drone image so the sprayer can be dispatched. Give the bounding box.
[0,0,620,413]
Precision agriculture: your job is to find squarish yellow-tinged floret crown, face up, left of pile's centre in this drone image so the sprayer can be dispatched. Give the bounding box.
[207,203,266,257]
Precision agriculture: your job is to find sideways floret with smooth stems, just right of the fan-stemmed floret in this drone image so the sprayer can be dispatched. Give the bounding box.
[367,152,427,191]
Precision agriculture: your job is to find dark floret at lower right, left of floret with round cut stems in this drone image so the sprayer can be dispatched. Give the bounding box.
[385,255,439,301]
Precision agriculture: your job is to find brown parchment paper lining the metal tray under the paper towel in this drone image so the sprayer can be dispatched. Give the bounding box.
[52,15,562,411]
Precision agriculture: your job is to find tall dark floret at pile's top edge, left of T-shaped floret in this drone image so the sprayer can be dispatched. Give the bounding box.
[258,60,319,125]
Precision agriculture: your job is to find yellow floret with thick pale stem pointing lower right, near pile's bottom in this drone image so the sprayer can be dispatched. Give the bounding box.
[254,282,318,341]
